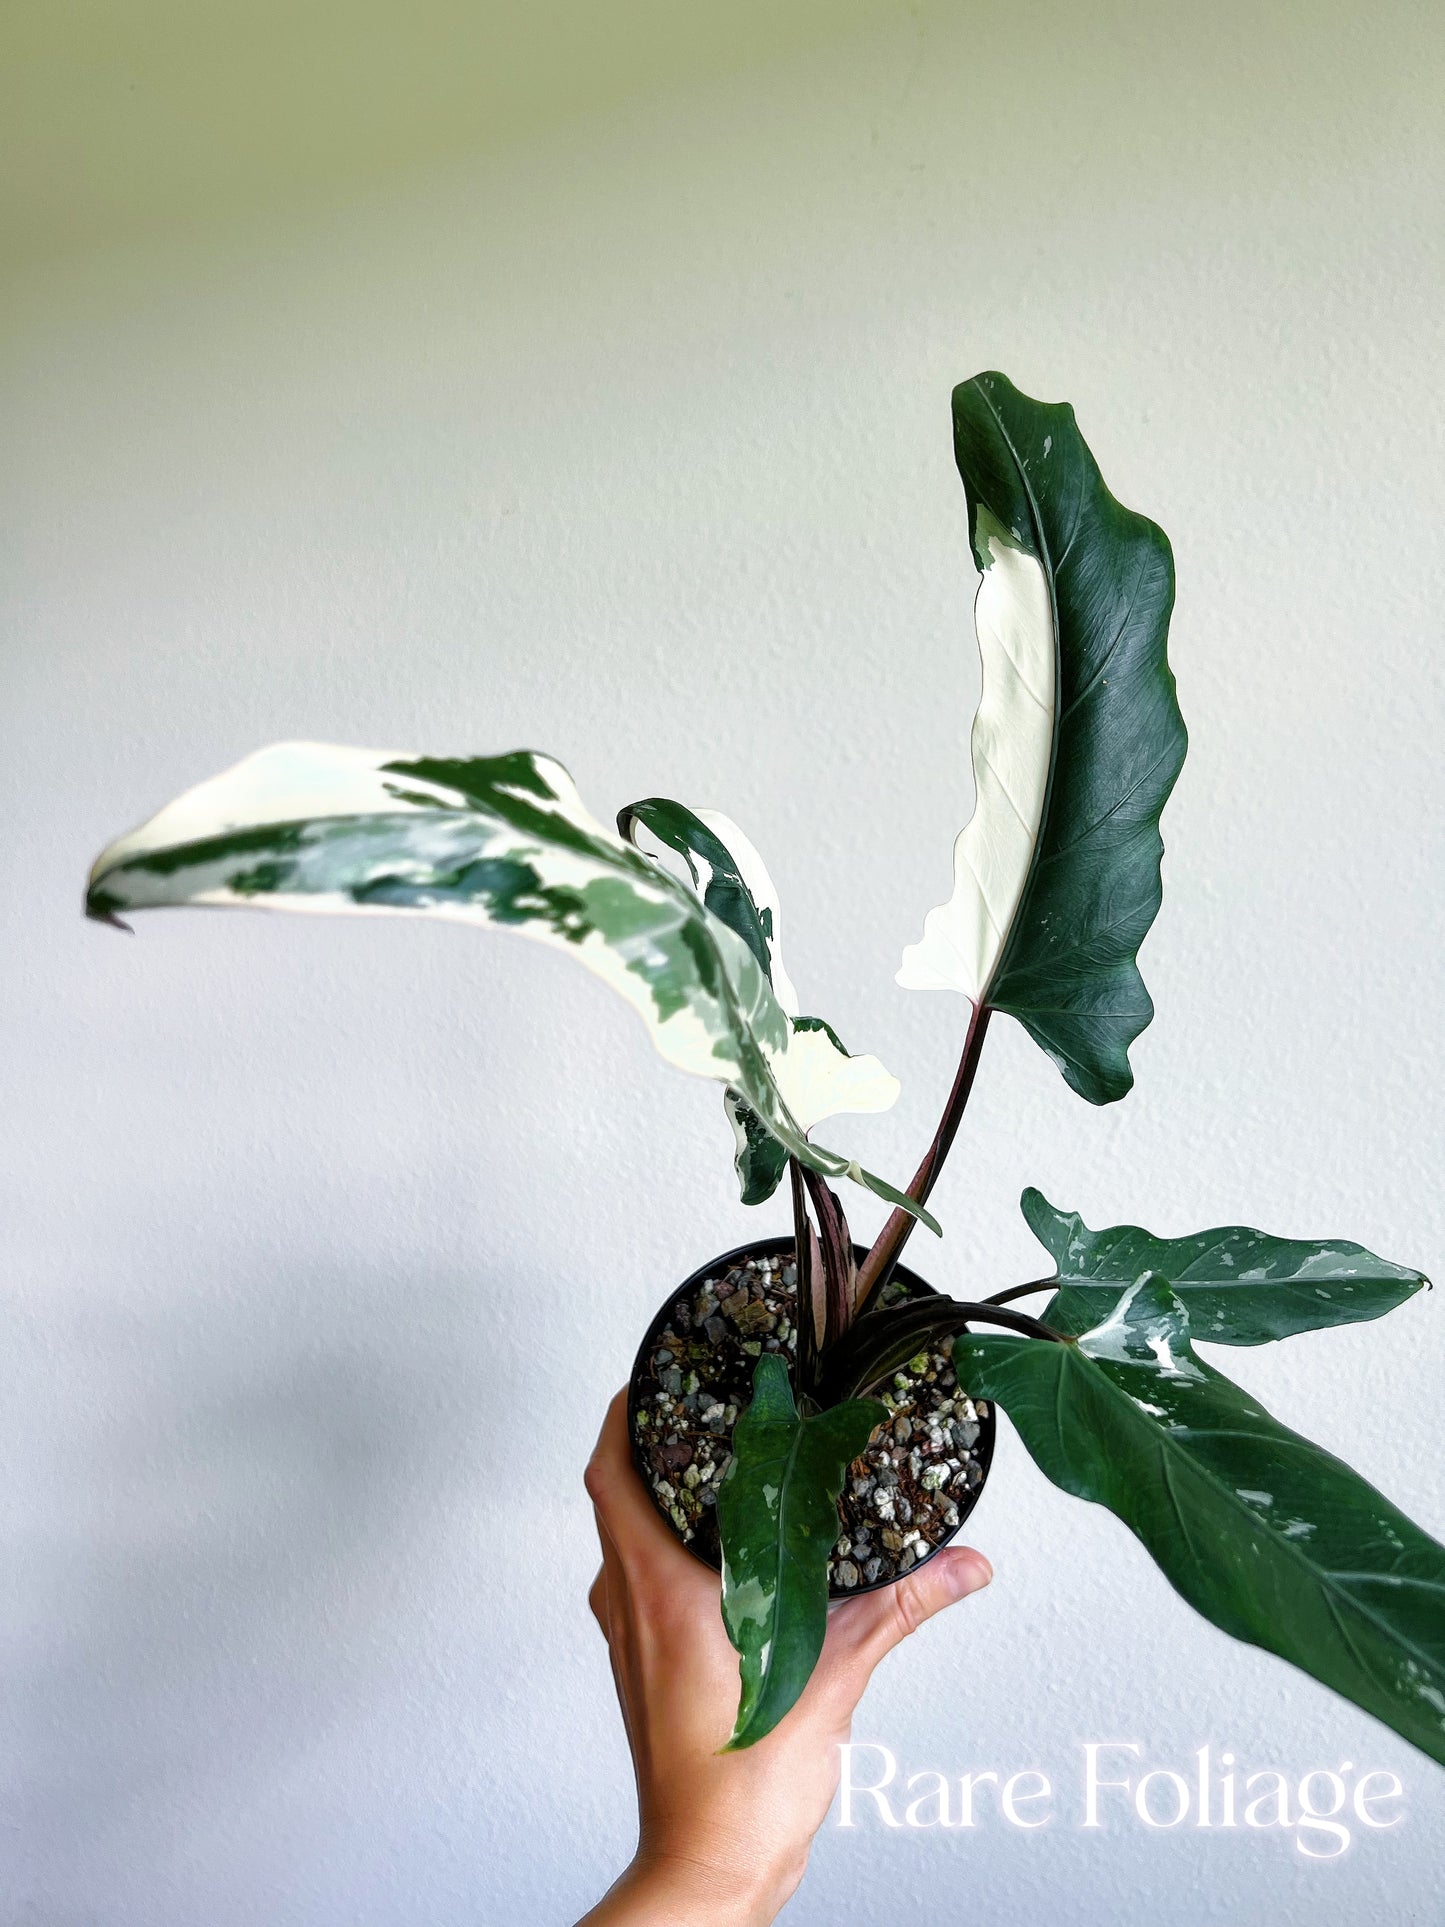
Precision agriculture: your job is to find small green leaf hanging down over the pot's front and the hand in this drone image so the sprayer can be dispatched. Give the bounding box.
[717,1353,888,1752]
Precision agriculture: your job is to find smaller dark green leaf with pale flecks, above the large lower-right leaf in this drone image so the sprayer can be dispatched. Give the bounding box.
[1021,1189,1428,1345]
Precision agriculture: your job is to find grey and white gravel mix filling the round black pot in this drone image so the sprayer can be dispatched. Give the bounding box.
[632,1254,988,1597]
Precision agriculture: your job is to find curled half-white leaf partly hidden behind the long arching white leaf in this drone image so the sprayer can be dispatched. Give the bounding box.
[617,796,900,1204]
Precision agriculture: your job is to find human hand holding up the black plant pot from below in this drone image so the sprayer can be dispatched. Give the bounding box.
[578,1391,992,1927]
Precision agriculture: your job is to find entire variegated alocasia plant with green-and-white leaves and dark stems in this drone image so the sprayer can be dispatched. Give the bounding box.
[87,374,1445,1763]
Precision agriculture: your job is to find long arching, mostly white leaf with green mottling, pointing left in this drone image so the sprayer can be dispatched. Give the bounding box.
[87,744,936,1229]
